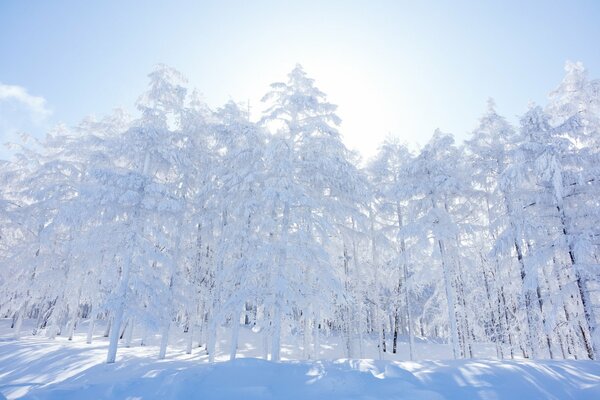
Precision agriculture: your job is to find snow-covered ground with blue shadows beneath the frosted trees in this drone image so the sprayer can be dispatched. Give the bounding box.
[0,319,600,400]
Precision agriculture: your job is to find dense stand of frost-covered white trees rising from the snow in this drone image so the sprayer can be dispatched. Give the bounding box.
[0,62,600,363]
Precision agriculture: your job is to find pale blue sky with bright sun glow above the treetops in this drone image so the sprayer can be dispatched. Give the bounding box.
[0,0,600,157]
